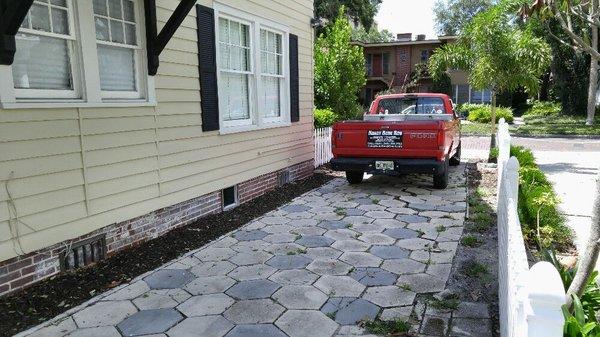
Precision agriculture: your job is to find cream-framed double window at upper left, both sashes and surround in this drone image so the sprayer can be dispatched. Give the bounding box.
[0,0,154,108]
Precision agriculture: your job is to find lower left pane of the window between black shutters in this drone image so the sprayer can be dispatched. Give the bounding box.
[219,72,250,121]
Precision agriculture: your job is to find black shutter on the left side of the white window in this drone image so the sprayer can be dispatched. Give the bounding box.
[196,5,219,131]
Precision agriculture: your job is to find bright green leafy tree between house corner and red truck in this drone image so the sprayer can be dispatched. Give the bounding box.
[315,6,366,119]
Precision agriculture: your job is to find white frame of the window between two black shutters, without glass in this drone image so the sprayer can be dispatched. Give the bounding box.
[213,3,291,134]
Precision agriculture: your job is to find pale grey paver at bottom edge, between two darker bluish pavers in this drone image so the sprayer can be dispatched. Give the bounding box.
[167,316,233,337]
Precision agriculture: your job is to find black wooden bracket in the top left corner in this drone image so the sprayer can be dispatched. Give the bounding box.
[0,0,33,65]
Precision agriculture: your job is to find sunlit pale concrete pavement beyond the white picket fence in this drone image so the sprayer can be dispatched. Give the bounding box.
[463,137,600,251]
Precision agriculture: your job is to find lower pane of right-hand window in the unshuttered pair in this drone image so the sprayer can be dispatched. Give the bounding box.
[98,45,136,91]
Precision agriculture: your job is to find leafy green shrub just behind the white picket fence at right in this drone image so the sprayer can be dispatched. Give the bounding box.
[510,146,572,249]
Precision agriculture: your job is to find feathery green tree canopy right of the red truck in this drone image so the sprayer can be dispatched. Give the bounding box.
[429,1,551,93]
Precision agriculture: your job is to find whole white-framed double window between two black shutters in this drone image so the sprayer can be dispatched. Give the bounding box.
[215,4,290,133]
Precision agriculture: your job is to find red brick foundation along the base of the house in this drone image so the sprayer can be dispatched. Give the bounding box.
[0,160,314,296]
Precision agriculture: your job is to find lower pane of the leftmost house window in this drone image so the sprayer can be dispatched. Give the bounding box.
[12,34,73,90]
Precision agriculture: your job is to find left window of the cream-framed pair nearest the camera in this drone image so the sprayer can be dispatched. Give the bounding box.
[12,0,79,98]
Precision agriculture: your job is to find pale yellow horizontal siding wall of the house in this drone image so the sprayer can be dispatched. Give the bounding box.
[0,0,313,261]
